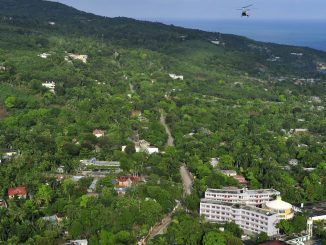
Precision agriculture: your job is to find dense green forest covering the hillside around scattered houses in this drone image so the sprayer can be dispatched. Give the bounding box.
[0,0,326,245]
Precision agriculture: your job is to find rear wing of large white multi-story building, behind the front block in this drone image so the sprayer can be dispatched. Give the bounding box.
[205,187,280,206]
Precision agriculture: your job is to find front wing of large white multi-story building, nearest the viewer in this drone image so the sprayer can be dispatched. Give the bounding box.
[200,199,279,236]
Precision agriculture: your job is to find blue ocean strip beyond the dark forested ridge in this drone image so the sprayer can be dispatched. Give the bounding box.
[155,17,326,51]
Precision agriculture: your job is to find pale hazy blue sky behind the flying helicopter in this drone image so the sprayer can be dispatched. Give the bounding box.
[51,0,326,20]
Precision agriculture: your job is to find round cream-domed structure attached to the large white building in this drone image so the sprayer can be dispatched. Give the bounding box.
[264,196,294,219]
